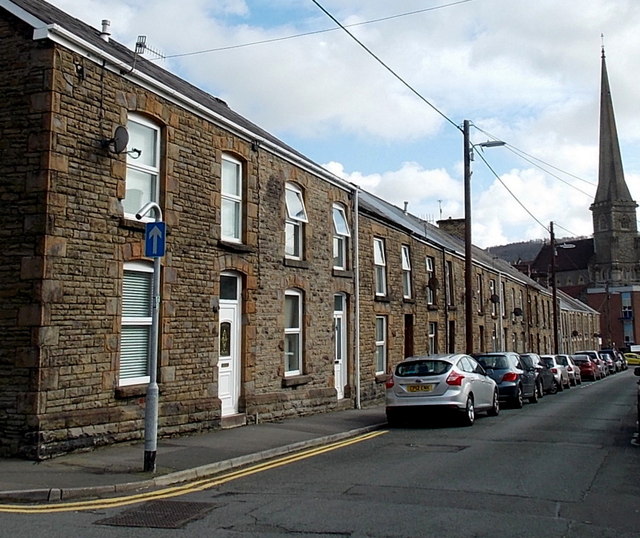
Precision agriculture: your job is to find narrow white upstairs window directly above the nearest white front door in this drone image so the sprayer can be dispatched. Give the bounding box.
[220,154,243,243]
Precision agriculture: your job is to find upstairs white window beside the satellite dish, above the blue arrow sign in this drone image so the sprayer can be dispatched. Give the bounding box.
[122,116,160,220]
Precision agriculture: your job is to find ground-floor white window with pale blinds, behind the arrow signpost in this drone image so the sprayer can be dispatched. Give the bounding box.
[118,262,153,387]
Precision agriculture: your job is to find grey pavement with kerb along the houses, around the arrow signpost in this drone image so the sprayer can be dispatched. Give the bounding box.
[0,407,386,504]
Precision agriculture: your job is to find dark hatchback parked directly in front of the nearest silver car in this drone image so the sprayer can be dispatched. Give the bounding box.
[472,351,538,409]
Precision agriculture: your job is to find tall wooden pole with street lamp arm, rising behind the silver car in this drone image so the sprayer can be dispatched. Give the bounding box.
[462,120,505,353]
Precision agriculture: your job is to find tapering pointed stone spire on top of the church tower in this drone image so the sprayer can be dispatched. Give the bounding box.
[594,44,632,204]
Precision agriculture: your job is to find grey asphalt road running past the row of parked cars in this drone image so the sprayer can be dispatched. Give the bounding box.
[0,371,640,538]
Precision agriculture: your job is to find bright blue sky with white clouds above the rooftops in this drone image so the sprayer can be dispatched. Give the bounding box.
[49,0,640,248]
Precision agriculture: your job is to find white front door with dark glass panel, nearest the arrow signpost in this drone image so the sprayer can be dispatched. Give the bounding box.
[218,274,242,416]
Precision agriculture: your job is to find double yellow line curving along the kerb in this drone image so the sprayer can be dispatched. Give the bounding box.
[0,430,387,514]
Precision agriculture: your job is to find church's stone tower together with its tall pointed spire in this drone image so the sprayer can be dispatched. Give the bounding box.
[590,47,640,289]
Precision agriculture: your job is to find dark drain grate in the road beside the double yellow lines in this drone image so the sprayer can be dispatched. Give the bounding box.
[95,501,216,529]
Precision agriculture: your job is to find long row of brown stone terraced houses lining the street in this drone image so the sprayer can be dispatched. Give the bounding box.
[0,0,597,460]
